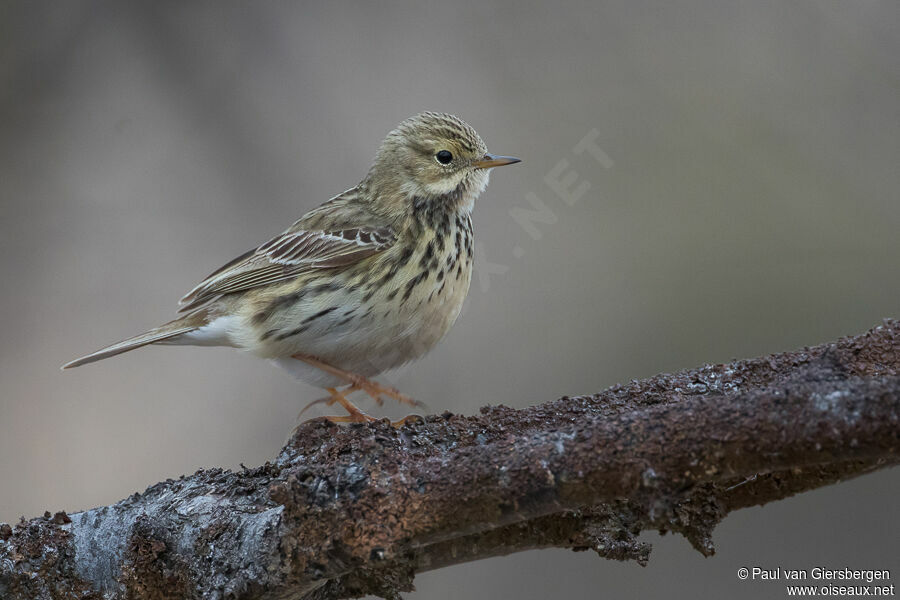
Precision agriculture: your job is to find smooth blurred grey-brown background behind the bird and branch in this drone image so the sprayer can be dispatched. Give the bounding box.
[0,0,900,599]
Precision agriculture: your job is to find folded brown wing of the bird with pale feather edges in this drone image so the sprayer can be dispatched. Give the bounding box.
[179,222,397,312]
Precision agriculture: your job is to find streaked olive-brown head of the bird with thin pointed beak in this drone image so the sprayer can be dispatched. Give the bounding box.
[366,112,519,218]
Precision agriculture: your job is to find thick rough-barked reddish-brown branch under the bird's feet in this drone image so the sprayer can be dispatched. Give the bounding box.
[0,321,900,600]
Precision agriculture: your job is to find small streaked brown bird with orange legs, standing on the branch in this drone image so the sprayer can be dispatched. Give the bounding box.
[62,112,521,423]
